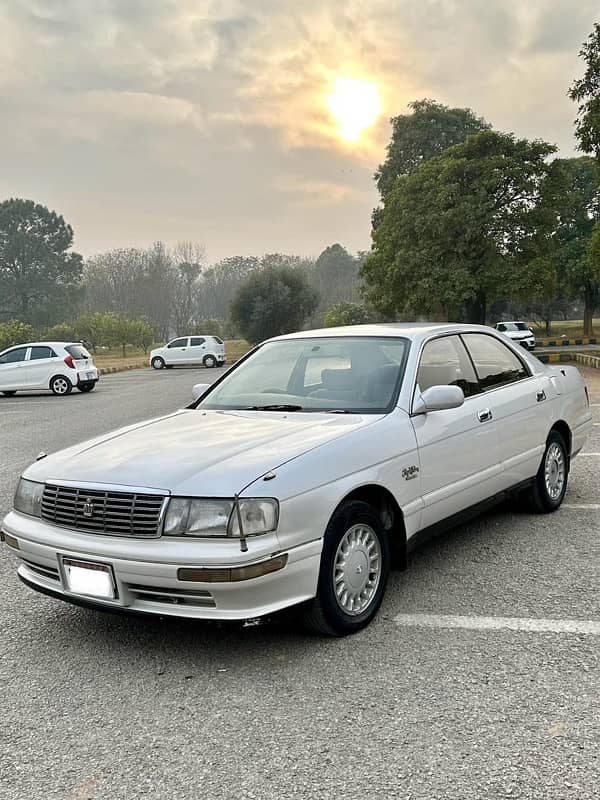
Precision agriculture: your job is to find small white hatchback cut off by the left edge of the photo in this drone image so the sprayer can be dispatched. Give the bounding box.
[0,342,98,397]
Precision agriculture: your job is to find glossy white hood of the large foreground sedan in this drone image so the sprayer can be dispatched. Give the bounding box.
[24,409,381,497]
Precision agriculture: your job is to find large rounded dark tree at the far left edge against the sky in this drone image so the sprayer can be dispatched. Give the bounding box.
[0,198,82,322]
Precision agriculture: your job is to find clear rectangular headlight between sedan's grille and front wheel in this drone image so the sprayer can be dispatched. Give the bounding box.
[163,497,279,538]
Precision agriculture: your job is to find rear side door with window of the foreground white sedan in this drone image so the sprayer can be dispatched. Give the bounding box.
[462,333,550,489]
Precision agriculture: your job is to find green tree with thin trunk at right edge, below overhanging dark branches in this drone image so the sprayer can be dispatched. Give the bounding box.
[542,156,600,336]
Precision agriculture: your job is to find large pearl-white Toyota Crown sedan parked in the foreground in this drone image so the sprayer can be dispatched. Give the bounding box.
[2,325,592,635]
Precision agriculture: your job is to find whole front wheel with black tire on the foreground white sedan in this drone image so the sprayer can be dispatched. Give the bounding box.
[302,501,390,636]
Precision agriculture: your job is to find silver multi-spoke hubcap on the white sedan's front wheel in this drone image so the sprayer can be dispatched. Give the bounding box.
[333,524,381,616]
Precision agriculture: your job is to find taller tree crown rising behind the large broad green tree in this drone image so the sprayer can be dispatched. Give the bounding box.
[375,99,490,199]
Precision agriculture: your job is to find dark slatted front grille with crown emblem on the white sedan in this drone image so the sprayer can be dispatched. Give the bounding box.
[42,484,165,537]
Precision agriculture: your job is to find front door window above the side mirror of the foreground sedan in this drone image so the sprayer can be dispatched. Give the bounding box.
[417,336,480,397]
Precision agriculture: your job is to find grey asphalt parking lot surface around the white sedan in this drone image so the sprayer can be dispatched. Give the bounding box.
[0,370,600,800]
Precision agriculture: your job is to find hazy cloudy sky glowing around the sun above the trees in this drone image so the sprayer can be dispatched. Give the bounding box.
[0,0,600,260]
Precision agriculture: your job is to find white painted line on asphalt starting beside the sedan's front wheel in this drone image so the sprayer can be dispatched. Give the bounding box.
[394,614,600,636]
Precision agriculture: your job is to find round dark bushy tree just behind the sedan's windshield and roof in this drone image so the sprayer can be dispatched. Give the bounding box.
[231,267,319,343]
